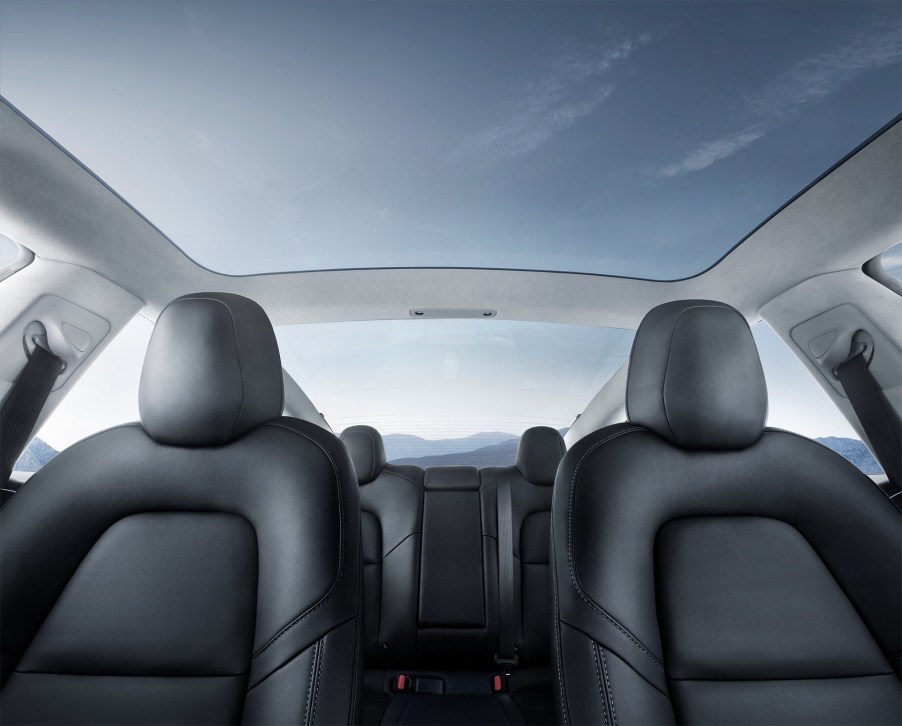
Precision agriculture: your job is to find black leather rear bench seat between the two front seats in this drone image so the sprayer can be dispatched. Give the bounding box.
[341,426,564,724]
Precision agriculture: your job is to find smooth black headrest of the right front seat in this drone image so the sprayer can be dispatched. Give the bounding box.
[626,300,767,449]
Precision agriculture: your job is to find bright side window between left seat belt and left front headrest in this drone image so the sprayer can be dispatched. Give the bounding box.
[13,315,153,472]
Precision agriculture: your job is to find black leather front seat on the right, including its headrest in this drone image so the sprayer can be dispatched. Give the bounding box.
[552,301,902,725]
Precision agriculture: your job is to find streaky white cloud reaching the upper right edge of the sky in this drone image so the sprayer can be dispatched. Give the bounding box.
[655,17,902,179]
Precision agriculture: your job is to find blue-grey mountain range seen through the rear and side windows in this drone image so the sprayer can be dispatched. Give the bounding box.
[13,436,883,474]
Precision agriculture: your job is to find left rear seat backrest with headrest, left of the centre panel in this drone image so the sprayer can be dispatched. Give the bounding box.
[340,426,423,667]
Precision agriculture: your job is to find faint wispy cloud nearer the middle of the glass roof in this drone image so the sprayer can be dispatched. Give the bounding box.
[460,35,651,162]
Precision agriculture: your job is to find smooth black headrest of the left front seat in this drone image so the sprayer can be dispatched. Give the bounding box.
[139,292,283,446]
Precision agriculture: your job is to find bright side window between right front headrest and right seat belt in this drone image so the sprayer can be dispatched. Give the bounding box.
[752,321,883,474]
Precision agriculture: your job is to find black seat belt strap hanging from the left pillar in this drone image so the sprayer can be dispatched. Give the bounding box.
[0,345,64,488]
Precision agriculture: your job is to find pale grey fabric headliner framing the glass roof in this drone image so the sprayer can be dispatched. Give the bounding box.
[0,103,902,328]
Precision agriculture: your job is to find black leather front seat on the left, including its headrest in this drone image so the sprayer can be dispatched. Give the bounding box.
[0,294,361,724]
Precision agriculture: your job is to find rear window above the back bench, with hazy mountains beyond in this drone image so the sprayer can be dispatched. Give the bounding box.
[276,319,634,466]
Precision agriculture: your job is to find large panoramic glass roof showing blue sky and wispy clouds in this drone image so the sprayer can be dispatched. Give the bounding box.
[0,0,902,279]
